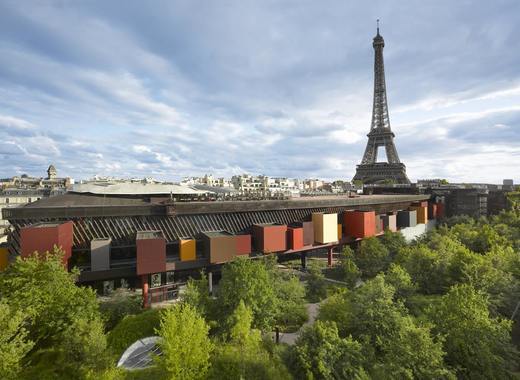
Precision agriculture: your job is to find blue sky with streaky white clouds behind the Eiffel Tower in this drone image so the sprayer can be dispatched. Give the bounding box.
[0,0,520,183]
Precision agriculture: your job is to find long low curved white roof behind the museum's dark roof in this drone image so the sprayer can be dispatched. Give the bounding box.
[72,181,211,195]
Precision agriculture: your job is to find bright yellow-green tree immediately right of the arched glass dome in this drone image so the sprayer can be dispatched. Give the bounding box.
[157,303,213,380]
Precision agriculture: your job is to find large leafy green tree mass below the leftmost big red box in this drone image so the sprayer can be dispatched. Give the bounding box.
[0,248,107,379]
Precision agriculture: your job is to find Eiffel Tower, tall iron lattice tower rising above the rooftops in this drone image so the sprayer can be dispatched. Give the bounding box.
[352,20,410,184]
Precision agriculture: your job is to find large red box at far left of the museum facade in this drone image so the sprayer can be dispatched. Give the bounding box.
[20,221,74,265]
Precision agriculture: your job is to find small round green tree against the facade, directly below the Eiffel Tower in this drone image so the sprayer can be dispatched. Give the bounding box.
[355,237,389,277]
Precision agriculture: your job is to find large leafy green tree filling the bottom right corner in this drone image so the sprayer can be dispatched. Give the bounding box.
[429,284,518,379]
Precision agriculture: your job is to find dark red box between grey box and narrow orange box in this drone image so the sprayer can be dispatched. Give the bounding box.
[135,231,166,276]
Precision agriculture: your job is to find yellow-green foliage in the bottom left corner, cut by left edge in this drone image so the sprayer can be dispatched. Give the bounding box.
[0,301,34,380]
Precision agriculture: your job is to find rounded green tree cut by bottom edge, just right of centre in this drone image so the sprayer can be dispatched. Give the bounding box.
[291,321,369,379]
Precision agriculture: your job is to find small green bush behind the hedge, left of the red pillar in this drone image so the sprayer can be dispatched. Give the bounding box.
[99,289,141,331]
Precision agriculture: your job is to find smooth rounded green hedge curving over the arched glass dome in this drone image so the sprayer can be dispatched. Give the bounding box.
[107,309,161,356]
